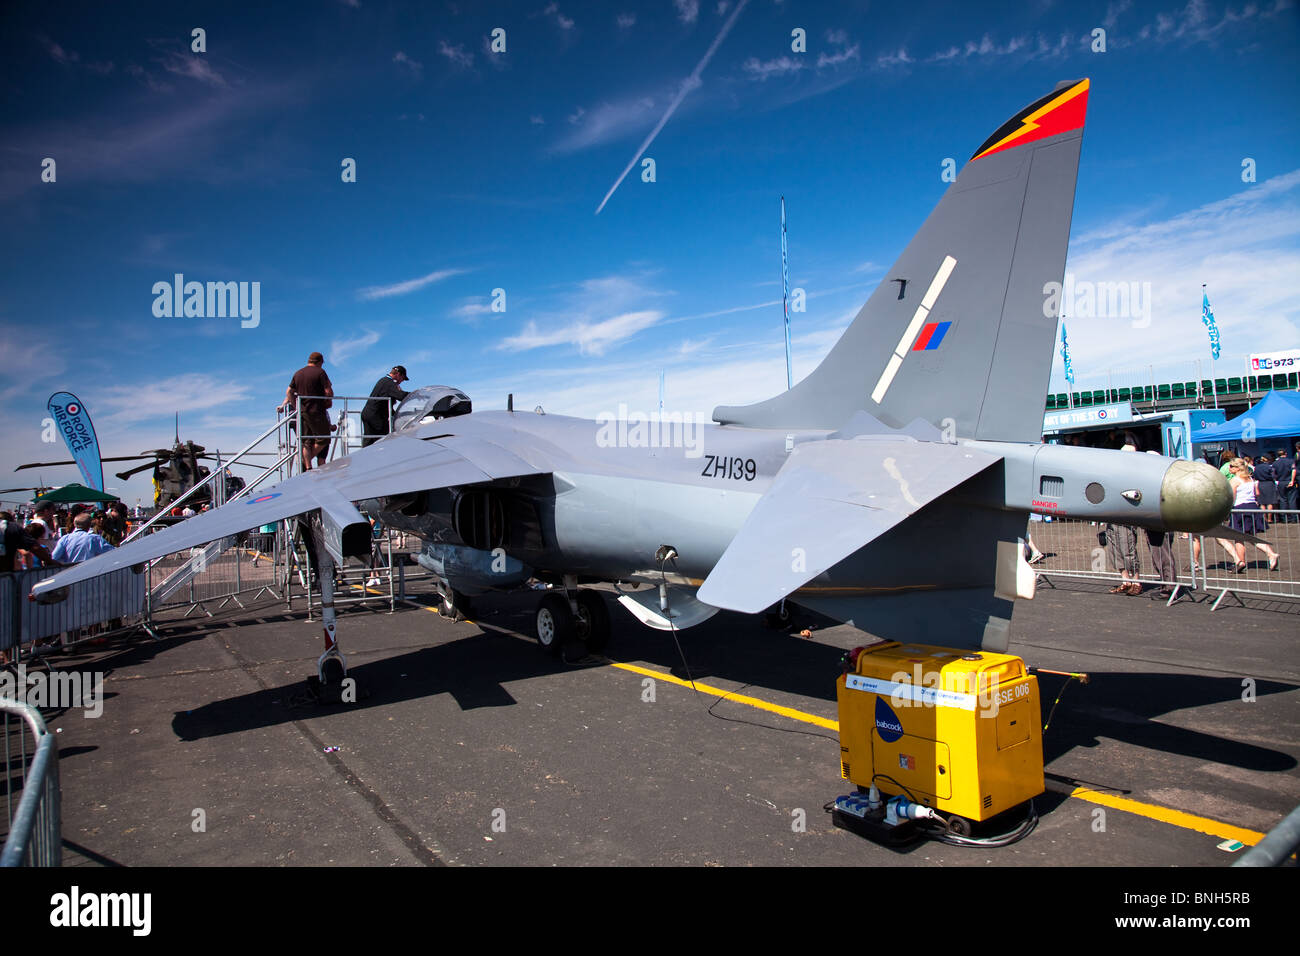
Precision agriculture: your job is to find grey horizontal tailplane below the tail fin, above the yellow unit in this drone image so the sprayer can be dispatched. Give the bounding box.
[697,437,1001,614]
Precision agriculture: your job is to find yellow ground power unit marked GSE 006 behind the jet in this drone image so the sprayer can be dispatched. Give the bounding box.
[837,641,1044,822]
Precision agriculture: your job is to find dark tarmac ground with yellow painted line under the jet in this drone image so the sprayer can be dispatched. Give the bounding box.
[7,579,1300,866]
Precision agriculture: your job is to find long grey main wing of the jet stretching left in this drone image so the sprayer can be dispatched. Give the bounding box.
[33,434,547,597]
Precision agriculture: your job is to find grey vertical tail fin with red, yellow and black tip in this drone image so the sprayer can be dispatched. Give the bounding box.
[714,79,1088,441]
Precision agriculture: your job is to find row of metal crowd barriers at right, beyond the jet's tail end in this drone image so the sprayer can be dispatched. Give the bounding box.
[1028,511,1300,609]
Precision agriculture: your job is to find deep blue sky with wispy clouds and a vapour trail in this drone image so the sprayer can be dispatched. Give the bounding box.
[0,0,1300,502]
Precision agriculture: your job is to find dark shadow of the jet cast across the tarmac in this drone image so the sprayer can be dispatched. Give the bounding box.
[153,594,1296,773]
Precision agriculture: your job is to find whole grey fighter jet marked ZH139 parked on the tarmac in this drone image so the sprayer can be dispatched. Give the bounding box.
[35,79,1232,671]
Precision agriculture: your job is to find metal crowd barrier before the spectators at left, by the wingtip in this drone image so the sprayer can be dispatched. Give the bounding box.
[0,567,146,650]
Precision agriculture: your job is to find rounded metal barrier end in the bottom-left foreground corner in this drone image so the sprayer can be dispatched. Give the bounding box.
[0,697,64,866]
